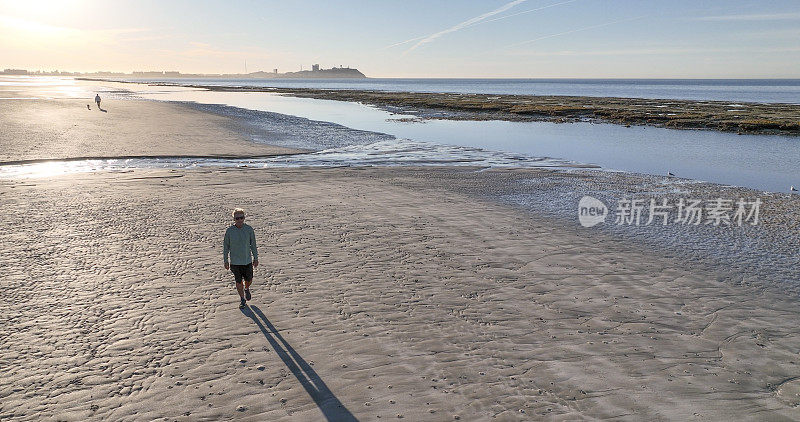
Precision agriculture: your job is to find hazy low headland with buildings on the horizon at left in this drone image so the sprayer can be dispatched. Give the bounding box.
[0,64,366,79]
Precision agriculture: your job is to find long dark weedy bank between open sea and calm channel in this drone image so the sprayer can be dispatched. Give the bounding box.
[76,78,800,136]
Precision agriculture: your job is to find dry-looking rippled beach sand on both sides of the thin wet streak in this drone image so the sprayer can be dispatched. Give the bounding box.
[0,90,800,421]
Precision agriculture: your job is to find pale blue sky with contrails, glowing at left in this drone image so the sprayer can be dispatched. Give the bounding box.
[0,0,800,78]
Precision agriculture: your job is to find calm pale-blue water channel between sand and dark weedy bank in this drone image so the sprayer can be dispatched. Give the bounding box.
[125,87,800,192]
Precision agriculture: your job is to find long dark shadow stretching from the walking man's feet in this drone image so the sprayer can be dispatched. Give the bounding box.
[242,306,358,422]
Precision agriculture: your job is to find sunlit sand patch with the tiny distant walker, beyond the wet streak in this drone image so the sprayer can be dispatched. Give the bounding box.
[0,99,296,162]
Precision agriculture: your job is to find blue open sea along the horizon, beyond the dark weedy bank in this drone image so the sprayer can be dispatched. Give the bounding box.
[130,78,800,104]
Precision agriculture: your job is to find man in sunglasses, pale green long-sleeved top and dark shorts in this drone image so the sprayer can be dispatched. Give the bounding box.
[222,208,258,309]
